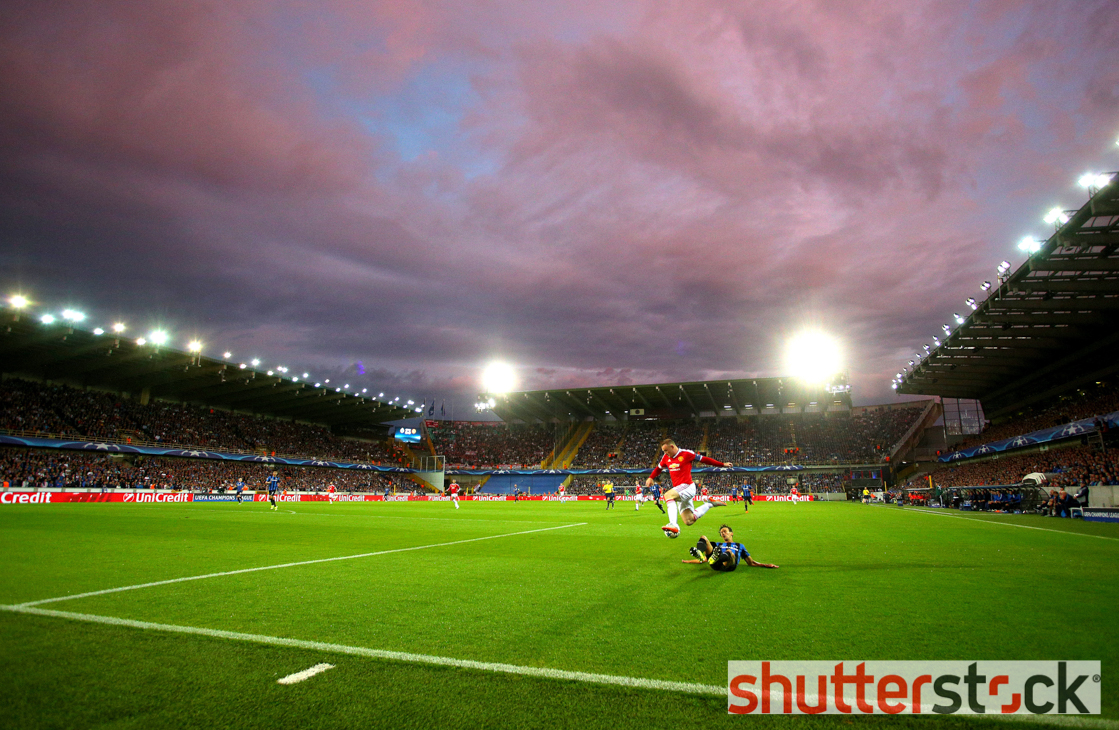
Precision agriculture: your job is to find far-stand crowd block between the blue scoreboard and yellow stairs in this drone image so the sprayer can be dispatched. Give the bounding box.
[429,421,562,469]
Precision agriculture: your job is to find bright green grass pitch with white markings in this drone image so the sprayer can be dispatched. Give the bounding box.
[0,502,1119,730]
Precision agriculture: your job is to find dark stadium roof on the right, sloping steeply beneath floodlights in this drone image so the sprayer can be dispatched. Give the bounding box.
[897,176,1119,418]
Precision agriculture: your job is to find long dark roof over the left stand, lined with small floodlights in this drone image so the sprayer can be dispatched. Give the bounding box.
[0,317,416,428]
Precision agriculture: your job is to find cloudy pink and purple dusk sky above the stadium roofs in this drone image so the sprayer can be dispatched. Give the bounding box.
[0,0,1119,415]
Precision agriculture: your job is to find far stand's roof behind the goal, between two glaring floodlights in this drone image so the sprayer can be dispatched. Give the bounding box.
[491,377,850,423]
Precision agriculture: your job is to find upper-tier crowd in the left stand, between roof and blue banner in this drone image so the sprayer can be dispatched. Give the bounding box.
[0,378,407,465]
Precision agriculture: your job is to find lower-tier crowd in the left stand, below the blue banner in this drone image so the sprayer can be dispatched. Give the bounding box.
[0,448,417,493]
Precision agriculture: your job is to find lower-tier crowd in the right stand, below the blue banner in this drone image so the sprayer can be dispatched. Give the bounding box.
[921,446,1119,488]
